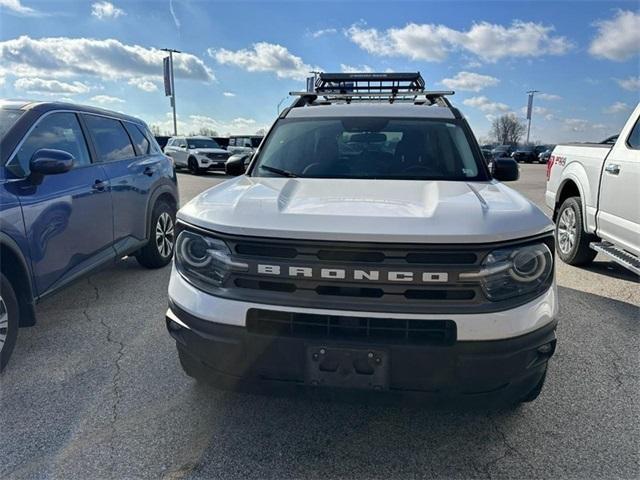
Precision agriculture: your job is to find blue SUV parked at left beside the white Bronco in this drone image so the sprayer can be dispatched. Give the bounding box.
[0,101,178,370]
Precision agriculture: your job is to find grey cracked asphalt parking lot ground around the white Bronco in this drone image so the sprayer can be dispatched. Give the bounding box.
[0,165,640,479]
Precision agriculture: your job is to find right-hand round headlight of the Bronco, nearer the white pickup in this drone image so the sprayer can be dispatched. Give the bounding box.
[460,243,553,301]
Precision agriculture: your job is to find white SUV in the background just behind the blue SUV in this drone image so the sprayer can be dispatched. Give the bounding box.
[164,136,230,175]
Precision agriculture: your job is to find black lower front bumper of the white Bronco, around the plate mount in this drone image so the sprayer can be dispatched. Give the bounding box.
[166,303,556,401]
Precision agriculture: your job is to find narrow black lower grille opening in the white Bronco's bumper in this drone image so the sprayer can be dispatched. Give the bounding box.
[247,308,456,345]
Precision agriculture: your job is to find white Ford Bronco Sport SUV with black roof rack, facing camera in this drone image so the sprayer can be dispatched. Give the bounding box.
[166,73,557,402]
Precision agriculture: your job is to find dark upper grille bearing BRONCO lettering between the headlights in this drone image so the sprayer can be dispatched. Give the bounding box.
[188,229,553,315]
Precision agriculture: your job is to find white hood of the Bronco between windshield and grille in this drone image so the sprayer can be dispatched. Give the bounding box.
[178,176,553,243]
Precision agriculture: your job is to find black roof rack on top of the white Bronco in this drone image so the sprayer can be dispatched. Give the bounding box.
[289,72,455,108]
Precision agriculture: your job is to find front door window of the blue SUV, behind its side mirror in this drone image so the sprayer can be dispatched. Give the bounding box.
[7,113,91,176]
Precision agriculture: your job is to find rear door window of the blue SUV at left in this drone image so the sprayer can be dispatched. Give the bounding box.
[84,115,135,162]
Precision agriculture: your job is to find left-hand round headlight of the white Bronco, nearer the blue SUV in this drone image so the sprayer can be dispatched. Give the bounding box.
[175,230,249,291]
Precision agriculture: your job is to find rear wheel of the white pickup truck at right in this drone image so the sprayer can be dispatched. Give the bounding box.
[556,197,598,266]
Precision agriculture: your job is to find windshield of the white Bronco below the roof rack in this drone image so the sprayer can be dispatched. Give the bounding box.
[252,117,486,180]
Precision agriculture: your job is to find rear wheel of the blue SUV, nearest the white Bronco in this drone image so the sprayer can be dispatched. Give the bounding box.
[136,201,176,268]
